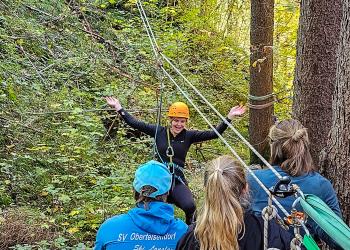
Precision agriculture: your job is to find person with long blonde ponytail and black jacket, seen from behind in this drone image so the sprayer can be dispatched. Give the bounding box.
[176,156,293,250]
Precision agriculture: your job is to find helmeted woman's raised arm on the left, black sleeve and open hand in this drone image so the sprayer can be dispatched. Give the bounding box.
[105,96,157,137]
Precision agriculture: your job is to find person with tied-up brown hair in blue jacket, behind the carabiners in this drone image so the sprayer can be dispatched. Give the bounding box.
[248,119,342,249]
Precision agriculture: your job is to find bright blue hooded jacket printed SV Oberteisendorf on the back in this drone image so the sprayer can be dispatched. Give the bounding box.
[95,201,187,250]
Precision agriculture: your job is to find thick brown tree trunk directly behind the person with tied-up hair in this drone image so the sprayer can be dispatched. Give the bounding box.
[293,0,342,166]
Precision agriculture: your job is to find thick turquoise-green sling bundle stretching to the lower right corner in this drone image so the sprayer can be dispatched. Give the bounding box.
[300,194,350,249]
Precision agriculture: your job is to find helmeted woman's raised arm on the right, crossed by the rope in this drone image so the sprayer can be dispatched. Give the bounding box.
[189,106,246,143]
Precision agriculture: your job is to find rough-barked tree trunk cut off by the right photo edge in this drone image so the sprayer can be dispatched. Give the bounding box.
[320,0,350,225]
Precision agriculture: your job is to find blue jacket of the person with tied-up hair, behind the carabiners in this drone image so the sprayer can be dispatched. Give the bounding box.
[248,166,341,247]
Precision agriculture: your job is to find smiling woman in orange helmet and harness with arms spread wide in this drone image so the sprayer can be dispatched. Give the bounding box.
[105,97,245,224]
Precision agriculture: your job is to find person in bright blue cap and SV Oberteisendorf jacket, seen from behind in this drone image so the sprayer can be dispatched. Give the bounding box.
[95,161,187,250]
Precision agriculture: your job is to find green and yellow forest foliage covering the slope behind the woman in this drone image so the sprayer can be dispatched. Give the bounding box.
[0,0,298,249]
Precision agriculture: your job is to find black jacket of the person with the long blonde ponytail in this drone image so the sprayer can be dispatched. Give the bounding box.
[176,211,293,250]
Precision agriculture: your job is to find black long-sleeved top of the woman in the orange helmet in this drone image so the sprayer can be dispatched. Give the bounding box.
[119,109,231,171]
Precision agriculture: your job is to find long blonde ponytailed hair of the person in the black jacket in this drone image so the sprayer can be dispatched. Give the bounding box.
[195,156,247,250]
